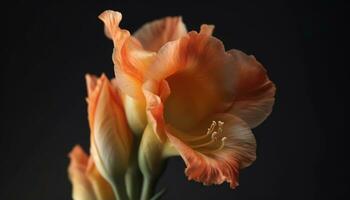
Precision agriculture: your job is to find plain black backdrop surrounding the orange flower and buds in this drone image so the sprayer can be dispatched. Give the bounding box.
[0,0,350,200]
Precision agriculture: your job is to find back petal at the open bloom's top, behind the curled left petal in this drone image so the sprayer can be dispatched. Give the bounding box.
[134,17,187,52]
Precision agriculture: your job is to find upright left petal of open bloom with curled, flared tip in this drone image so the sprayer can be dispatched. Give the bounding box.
[99,10,156,98]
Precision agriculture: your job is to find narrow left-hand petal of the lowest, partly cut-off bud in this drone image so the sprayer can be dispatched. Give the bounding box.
[68,145,97,200]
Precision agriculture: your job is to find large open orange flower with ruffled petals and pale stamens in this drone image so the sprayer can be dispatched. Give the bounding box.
[100,11,275,191]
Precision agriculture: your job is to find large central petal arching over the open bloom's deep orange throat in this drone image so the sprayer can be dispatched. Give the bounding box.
[148,27,237,129]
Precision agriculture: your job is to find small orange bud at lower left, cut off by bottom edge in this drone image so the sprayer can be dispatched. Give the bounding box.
[68,145,115,200]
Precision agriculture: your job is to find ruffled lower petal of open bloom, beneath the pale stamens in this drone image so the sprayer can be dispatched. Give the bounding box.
[167,114,256,188]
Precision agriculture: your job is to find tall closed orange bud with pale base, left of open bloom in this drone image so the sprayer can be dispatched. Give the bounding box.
[87,75,132,189]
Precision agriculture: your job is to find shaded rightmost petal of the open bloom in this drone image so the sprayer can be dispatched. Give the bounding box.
[228,50,276,128]
